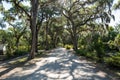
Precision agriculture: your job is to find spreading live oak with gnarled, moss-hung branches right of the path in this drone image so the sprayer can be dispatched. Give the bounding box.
[59,0,113,50]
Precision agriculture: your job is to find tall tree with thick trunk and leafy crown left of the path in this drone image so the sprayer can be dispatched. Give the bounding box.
[0,0,60,59]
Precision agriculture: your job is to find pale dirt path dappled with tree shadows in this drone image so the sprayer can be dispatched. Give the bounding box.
[0,48,118,80]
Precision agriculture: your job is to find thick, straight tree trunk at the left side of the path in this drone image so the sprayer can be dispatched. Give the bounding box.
[29,0,38,59]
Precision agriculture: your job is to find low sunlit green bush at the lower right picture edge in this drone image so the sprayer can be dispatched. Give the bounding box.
[105,53,120,68]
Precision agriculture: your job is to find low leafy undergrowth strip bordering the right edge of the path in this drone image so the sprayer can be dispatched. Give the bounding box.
[76,50,120,79]
